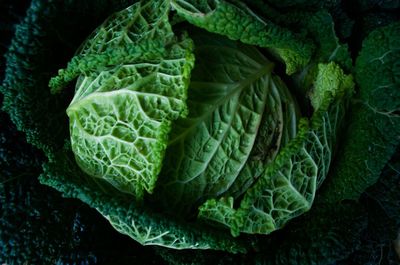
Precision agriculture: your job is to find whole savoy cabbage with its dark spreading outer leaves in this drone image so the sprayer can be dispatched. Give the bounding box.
[1,0,400,264]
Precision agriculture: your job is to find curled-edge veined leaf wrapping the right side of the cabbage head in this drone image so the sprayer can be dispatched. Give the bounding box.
[200,63,353,235]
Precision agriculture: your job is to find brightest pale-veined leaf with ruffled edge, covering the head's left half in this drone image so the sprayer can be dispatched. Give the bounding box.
[50,1,194,198]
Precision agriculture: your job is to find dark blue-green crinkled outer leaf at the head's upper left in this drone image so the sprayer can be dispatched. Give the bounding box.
[0,0,139,153]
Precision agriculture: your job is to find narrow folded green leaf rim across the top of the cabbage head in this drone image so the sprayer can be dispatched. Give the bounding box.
[171,0,313,74]
